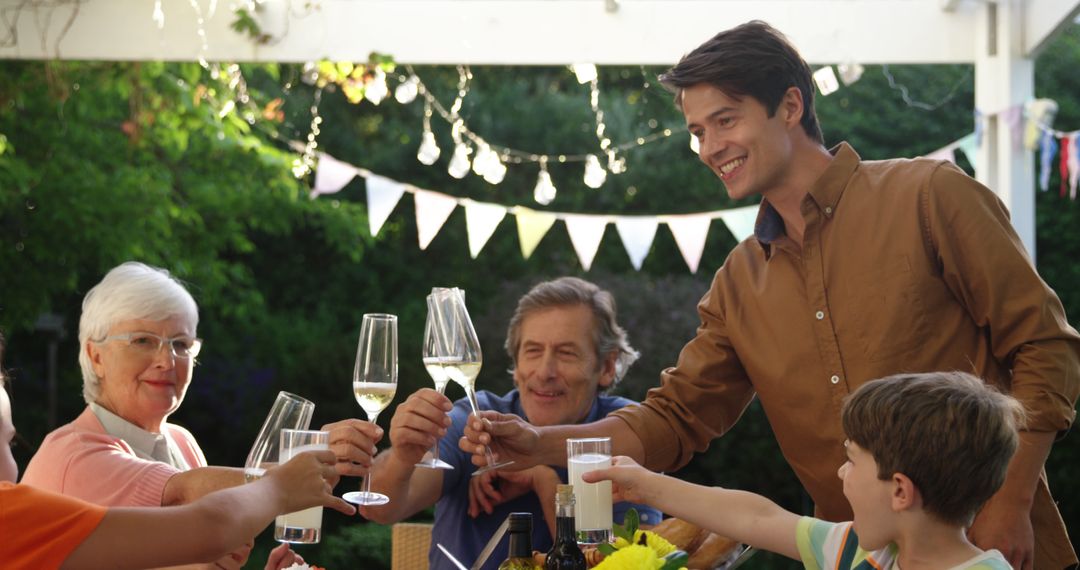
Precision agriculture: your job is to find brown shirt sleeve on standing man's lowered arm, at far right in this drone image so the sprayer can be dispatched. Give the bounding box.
[923,163,1080,432]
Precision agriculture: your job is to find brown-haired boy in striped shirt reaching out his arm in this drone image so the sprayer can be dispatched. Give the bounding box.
[584,372,1024,570]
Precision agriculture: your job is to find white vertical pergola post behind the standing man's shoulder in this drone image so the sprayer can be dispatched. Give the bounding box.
[975,0,1035,260]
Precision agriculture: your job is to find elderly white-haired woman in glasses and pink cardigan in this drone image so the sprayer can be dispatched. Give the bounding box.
[23,262,382,568]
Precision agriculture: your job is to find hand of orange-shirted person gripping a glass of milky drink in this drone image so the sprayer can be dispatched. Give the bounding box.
[270,451,356,515]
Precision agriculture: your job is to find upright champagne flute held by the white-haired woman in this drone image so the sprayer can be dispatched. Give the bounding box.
[342,314,397,505]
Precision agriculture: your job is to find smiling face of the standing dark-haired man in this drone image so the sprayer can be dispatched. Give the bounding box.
[681,83,801,200]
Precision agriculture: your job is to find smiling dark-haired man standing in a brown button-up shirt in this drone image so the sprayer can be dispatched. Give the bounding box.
[460,22,1080,570]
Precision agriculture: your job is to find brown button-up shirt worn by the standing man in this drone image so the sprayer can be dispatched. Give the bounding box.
[615,144,1080,569]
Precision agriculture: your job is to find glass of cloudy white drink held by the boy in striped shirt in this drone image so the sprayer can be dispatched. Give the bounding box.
[566,437,612,544]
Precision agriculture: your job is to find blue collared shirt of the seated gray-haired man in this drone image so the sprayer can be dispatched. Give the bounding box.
[428,390,662,570]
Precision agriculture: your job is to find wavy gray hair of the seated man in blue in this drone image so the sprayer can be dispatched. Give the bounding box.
[505,277,639,385]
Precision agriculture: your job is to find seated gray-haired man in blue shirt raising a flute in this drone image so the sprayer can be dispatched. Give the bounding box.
[361,277,661,570]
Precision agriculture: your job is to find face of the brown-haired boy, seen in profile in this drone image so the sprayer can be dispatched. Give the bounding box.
[837,440,895,551]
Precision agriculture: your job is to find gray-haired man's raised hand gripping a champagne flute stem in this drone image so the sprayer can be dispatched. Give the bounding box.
[390,388,454,463]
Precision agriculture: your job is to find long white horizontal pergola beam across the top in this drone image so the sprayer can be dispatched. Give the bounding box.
[0,0,980,65]
